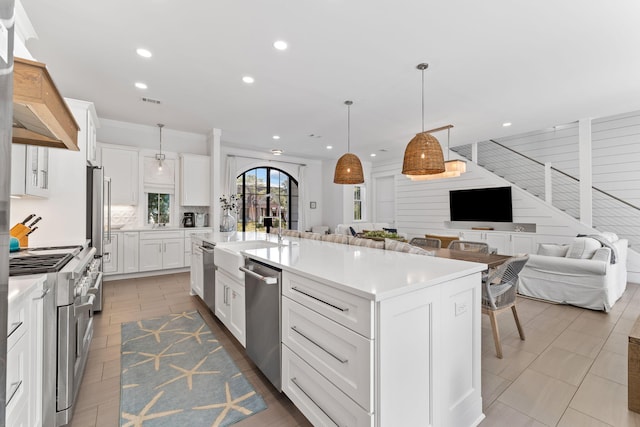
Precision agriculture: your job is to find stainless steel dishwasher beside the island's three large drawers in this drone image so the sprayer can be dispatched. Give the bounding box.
[240,258,282,391]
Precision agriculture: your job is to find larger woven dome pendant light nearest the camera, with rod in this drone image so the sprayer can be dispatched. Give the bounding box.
[402,63,445,176]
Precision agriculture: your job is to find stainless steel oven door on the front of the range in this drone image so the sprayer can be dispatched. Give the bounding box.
[56,294,95,426]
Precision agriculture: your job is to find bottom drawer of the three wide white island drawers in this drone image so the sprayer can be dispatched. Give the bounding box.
[282,346,374,427]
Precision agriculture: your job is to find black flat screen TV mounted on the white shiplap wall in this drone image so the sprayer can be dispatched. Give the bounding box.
[449,187,513,222]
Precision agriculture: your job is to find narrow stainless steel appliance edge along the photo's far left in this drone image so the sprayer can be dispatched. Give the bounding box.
[0,0,15,414]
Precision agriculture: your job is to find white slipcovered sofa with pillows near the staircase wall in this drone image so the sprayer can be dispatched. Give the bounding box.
[518,233,628,312]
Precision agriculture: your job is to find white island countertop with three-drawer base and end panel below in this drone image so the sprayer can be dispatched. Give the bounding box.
[196,233,486,427]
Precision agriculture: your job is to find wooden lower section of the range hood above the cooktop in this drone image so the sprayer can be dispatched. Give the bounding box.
[13,58,80,151]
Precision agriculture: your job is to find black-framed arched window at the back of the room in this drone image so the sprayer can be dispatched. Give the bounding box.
[236,167,298,232]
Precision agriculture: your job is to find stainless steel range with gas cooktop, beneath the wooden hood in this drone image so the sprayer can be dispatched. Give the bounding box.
[9,246,102,426]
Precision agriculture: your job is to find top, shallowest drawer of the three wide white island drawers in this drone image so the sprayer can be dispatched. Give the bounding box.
[282,271,374,339]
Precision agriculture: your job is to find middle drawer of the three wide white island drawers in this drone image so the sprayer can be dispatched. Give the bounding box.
[282,298,373,411]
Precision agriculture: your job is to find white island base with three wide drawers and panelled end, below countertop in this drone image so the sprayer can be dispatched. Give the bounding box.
[282,270,482,427]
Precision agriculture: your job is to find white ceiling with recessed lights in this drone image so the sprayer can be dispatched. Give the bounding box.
[17,0,640,161]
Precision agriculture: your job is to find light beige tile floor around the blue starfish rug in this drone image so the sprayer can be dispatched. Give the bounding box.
[71,273,640,427]
